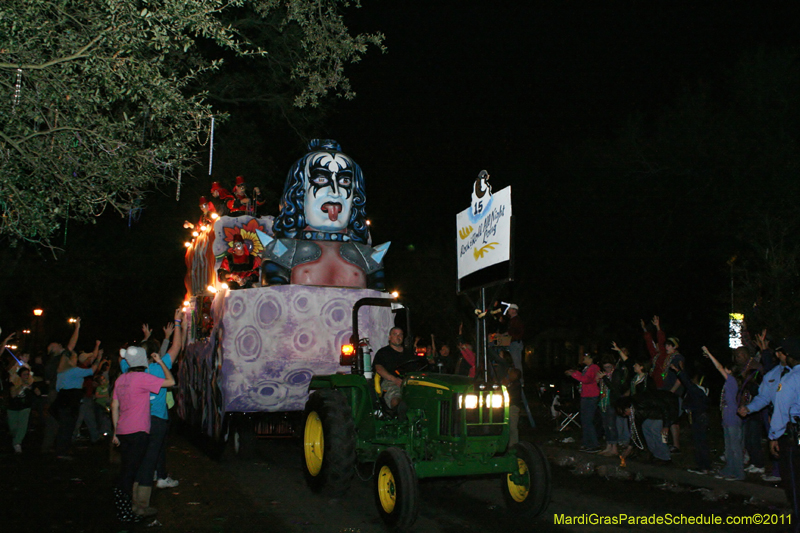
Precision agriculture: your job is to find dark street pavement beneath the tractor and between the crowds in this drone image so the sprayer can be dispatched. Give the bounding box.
[0,410,788,533]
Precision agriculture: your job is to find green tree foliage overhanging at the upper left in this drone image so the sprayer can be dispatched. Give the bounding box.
[0,0,382,246]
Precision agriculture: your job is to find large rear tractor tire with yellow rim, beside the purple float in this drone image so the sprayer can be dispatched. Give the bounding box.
[303,389,356,496]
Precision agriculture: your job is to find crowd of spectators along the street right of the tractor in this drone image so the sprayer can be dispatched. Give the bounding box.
[566,316,800,501]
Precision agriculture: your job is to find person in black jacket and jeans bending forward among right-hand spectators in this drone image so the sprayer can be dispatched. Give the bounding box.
[616,390,679,465]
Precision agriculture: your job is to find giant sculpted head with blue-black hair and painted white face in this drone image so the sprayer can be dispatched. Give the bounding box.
[273,139,368,243]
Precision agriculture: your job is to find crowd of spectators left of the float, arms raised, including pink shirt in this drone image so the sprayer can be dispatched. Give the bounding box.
[0,311,187,522]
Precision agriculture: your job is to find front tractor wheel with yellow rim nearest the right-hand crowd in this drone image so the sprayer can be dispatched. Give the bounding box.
[500,441,552,518]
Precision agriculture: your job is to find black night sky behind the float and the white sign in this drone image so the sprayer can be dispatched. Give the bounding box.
[0,0,800,360]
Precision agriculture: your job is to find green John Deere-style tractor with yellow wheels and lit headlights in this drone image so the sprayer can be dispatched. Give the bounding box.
[303,298,551,529]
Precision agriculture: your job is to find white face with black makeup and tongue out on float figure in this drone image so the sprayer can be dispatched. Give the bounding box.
[304,152,354,232]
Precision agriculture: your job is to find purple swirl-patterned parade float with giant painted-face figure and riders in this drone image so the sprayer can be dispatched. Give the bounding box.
[176,140,393,450]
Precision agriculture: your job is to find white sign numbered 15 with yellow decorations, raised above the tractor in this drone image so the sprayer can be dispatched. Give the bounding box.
[456,185,511,279]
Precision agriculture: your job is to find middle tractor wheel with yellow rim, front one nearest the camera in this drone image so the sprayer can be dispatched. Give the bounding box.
[374,448,419,530]
